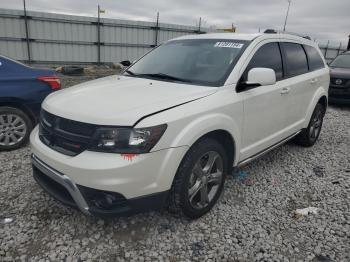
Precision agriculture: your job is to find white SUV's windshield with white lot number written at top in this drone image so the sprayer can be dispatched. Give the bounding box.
[124,39,248,86]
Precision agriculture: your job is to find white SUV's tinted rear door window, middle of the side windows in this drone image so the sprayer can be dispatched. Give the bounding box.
[282,43,309,77]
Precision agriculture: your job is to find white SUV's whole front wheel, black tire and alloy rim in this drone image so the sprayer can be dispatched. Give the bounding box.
[169,138,228,219]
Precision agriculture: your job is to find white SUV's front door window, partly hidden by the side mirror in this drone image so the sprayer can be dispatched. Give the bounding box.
[243,43,283,81]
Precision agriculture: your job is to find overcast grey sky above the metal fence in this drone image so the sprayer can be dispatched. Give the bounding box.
[0,0,350,45]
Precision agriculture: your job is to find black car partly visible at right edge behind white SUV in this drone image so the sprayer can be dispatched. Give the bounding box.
[329,51,350,104]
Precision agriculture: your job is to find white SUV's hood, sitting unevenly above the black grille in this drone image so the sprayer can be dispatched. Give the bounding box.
[43,76,218,126]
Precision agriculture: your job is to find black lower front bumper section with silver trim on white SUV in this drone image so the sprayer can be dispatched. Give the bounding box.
[31,154,168,217]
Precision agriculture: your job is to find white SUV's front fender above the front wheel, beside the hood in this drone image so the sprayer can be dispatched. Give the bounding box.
[137,87,244,164]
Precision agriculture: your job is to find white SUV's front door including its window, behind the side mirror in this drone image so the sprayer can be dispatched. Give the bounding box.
[238,42,288,161]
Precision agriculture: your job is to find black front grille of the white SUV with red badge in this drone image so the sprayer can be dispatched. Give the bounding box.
[39,110,96,156]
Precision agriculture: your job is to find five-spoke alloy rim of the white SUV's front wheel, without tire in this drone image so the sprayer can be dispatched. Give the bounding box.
[188,151,223,209]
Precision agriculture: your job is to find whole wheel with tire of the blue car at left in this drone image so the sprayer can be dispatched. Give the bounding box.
[0,107,33,151]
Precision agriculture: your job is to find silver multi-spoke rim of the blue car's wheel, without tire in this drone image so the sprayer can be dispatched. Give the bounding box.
[0,114,27,146]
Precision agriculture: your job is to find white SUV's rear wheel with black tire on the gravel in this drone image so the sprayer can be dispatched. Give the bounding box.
[294,104,326,147]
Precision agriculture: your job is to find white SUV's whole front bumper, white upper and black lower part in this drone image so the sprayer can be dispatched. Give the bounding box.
[30,128,188,215]
